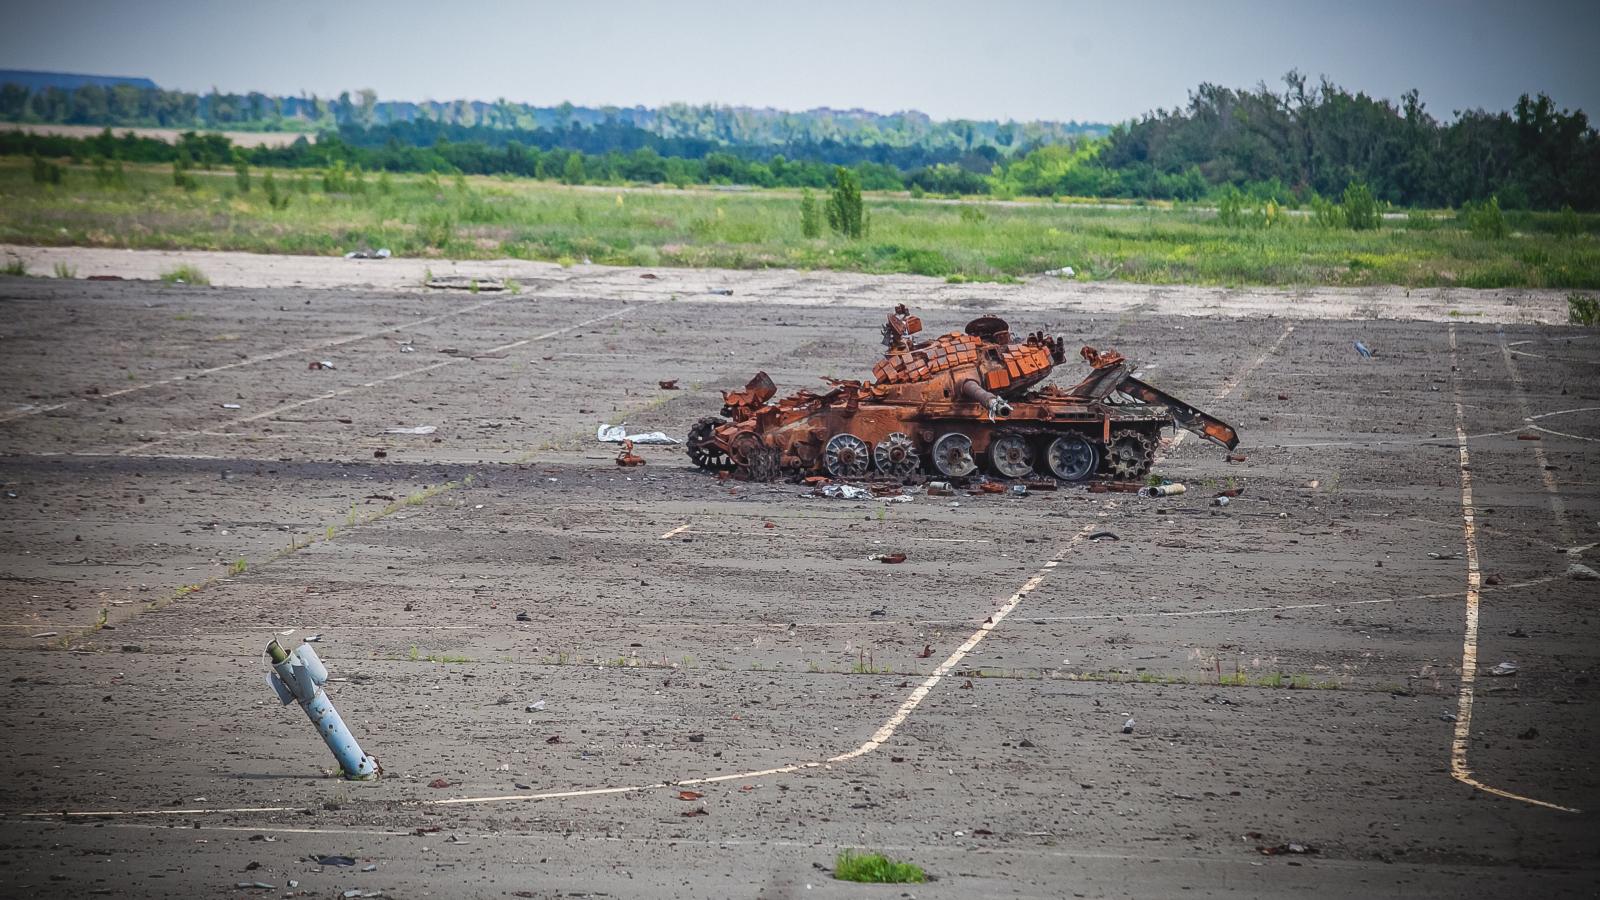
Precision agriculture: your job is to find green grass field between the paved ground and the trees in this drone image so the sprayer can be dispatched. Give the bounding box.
[0,159,1600,288]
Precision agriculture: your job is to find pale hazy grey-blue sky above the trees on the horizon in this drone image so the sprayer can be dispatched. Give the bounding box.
[0,0,1600,122]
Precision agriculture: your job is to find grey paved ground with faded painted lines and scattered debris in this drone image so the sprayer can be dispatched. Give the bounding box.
[0,263,1600,897]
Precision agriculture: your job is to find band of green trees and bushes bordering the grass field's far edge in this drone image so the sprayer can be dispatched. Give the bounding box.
[0,72,1600,211]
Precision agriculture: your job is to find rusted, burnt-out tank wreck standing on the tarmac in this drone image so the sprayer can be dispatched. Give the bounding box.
[686,306,1238,482]
